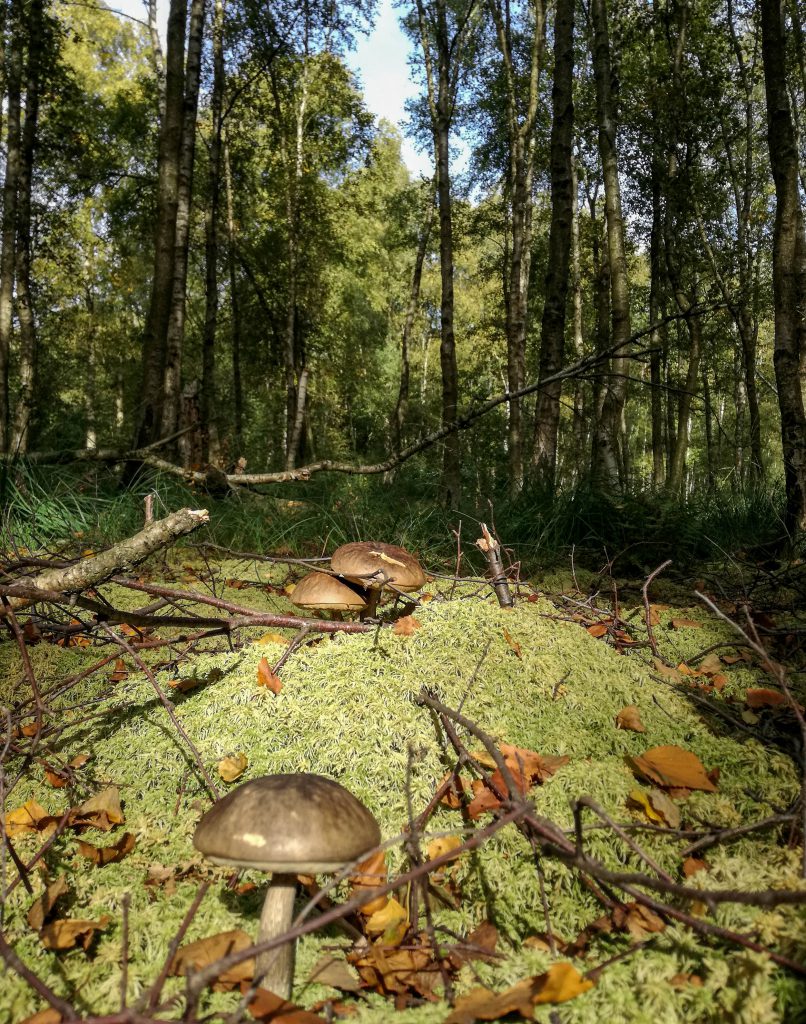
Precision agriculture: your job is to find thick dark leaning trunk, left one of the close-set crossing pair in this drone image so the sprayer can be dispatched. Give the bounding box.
[134,0,187,447]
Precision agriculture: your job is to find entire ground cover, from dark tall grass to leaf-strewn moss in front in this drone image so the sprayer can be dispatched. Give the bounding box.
[0,474,806,1024]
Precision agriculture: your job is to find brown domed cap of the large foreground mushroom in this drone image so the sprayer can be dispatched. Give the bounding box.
[194,772,381,874]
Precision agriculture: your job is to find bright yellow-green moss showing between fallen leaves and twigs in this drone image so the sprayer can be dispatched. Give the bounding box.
[0,577,806,1024]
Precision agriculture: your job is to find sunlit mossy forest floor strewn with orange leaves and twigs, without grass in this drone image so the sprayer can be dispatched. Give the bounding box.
[0,520,806,1024]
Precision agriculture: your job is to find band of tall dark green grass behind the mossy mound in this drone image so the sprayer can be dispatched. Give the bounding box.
[0,464,783,574]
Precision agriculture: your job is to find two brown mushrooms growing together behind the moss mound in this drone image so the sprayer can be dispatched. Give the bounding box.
[291,541,425,616]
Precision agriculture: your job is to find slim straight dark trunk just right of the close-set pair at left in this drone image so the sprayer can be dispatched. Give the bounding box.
[199,0,224,464]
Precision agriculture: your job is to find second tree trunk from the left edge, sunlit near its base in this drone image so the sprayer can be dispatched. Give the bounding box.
[11,0,45,455]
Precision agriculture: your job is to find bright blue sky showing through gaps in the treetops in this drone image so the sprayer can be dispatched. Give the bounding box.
[108,0,431,176]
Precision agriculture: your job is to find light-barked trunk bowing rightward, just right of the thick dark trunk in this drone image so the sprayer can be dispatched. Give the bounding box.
[591,0,631,489]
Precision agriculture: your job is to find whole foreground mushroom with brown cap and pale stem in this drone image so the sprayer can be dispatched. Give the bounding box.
[194,772,381,999]
